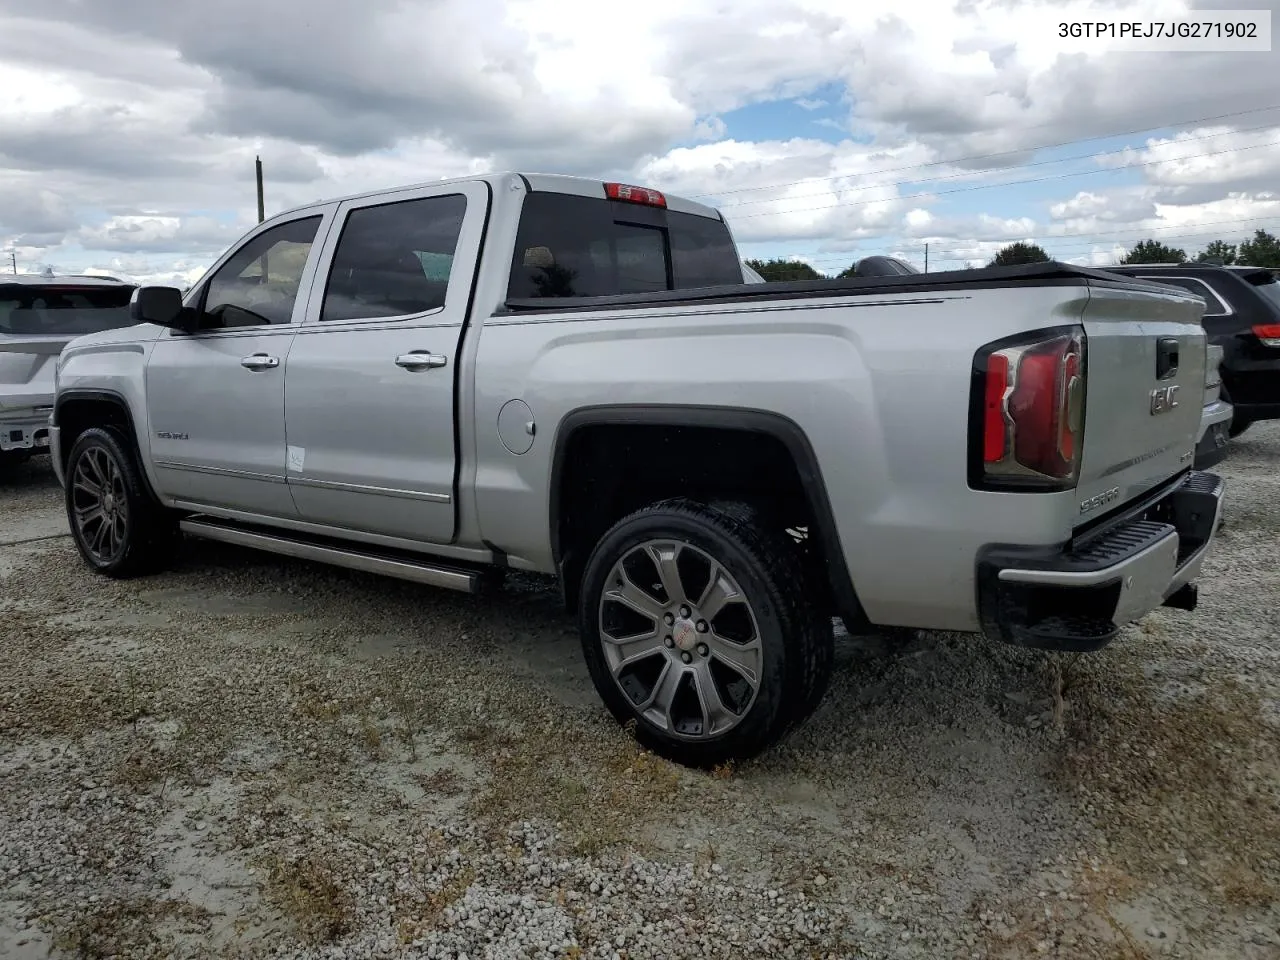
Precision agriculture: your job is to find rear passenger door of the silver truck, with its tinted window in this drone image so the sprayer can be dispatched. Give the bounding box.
[284,183,489,543]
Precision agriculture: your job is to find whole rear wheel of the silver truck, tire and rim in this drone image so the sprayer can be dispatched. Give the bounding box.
[580,499,835,767]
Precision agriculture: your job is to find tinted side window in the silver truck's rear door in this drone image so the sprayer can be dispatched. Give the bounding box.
[320,195,467,321]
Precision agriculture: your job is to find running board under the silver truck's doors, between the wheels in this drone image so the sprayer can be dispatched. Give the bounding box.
[178,517,483,594]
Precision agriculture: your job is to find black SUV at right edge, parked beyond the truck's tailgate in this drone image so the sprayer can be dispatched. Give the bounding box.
[1107,264,1280,436]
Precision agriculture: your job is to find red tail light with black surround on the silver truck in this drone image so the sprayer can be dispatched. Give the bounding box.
[969,328,1085,490]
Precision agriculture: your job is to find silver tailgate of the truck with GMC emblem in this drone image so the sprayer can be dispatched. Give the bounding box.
[1075,283,1206,526]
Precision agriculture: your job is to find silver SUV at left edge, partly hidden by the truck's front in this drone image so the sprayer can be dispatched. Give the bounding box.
[0,274,134,467]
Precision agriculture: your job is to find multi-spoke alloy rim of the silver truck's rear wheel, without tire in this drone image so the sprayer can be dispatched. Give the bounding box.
[599,540,763,740]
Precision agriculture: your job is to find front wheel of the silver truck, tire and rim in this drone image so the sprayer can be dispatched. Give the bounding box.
[64,426,180,580]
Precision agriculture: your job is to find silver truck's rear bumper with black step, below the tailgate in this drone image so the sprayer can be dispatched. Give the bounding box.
[978,471,1225,652]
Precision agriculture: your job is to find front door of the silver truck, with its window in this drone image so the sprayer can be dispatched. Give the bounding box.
[146,214,326,517]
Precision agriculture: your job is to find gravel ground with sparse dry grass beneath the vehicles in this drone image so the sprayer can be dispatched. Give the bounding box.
[0,426,1280,960]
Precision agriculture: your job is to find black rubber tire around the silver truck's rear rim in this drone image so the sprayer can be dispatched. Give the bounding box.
[579,499,835,767]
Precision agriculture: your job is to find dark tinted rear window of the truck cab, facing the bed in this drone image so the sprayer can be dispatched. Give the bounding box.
[507,192,742,300]
